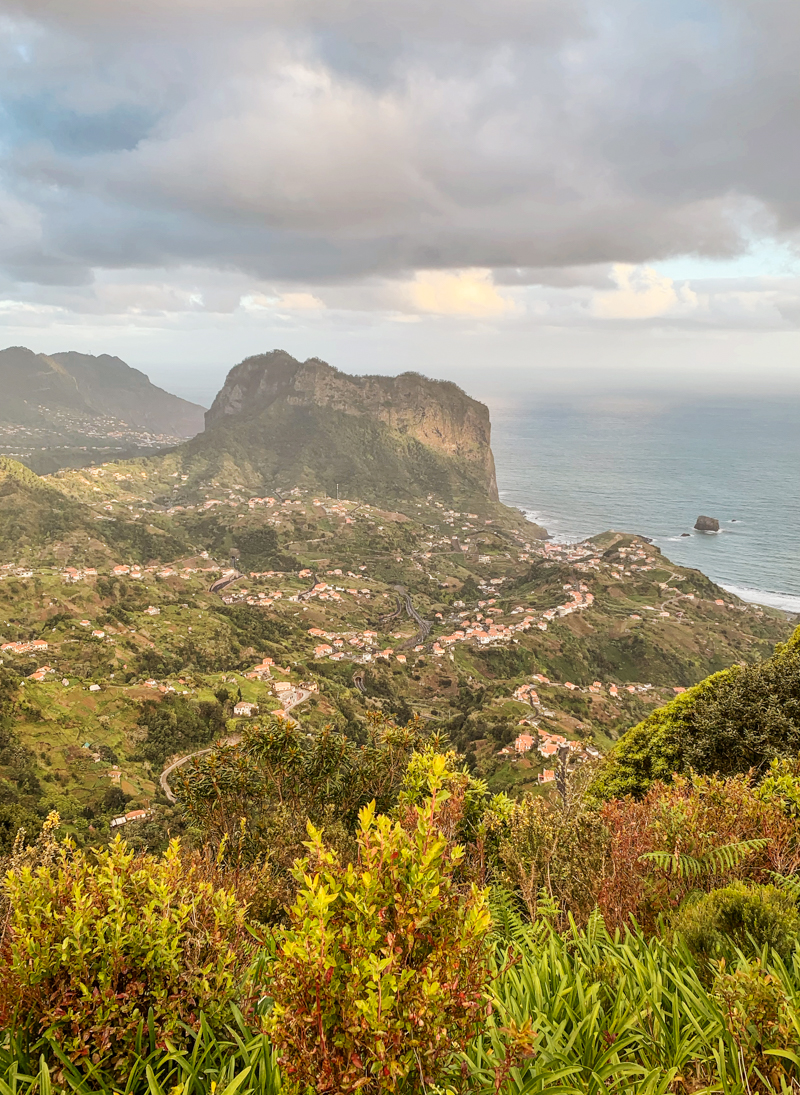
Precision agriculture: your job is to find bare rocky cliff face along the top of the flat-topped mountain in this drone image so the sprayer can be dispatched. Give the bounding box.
[206,350,498,500]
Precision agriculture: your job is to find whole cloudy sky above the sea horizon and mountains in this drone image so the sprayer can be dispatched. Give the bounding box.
[0,0,800,403]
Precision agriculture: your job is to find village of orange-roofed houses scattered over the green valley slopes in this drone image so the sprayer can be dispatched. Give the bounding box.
[0,468,783,826]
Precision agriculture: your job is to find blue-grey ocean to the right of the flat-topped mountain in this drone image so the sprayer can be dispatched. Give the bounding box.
[485,393,800,612]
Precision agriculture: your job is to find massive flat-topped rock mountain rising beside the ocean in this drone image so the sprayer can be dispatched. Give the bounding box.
[181,350,498,502]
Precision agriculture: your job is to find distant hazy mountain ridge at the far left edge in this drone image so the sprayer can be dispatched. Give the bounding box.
[0,346,202,441]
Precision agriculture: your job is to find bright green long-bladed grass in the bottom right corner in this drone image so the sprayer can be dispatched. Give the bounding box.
[465,898,800,1095]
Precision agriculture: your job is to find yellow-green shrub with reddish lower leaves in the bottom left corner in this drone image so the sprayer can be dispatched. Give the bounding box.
[0,838,253,1068]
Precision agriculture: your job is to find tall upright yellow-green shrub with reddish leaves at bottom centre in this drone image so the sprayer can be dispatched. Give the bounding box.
[268,785,491,1095]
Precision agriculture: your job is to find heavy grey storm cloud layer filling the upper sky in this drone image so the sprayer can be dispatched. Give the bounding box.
[0,0,800,286]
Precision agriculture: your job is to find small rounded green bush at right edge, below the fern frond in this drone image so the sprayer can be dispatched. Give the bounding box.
[673,881,800,958]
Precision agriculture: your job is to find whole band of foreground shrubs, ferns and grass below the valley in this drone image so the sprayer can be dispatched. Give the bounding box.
[0,674,800,1095]
